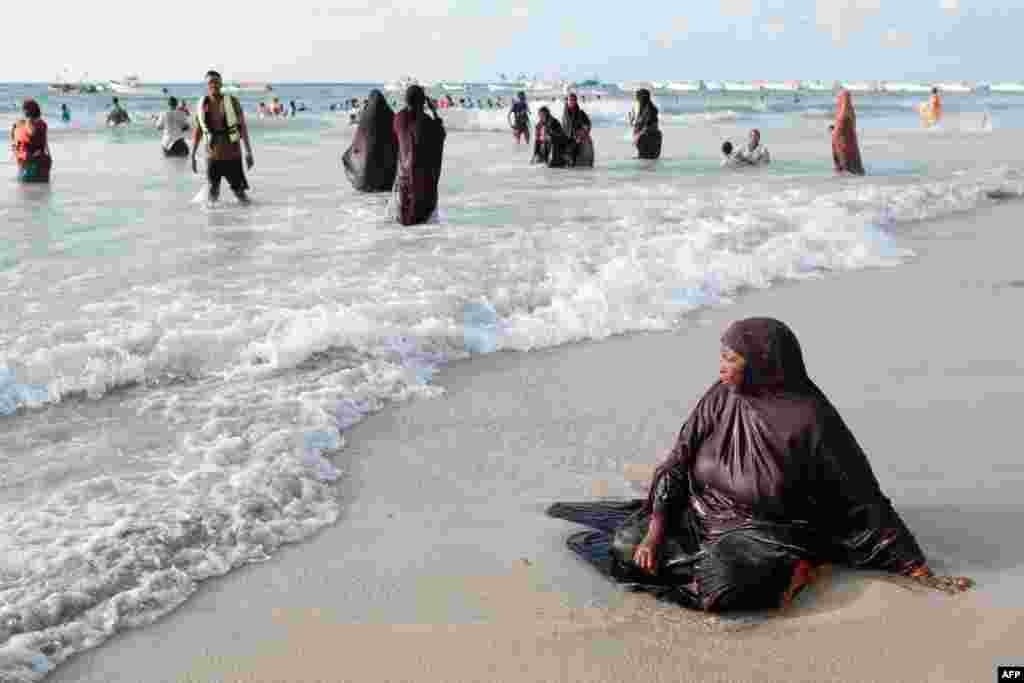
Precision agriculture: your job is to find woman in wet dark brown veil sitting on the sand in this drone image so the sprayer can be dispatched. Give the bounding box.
[549,318,970,611]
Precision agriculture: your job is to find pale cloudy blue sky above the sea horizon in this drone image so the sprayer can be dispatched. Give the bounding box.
[6,0,1024,82]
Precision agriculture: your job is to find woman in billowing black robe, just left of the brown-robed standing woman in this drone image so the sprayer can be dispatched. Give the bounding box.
[341,90,398,193]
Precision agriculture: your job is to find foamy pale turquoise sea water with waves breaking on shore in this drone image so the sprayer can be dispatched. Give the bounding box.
[6,85,1024,681]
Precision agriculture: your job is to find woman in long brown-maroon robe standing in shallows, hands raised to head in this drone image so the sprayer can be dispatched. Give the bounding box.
[394,85,445,225]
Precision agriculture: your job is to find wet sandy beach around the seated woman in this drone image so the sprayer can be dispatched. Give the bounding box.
[44,181,1024,683]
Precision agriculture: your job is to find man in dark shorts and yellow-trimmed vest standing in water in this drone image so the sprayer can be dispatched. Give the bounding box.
[191,71,255,204]
